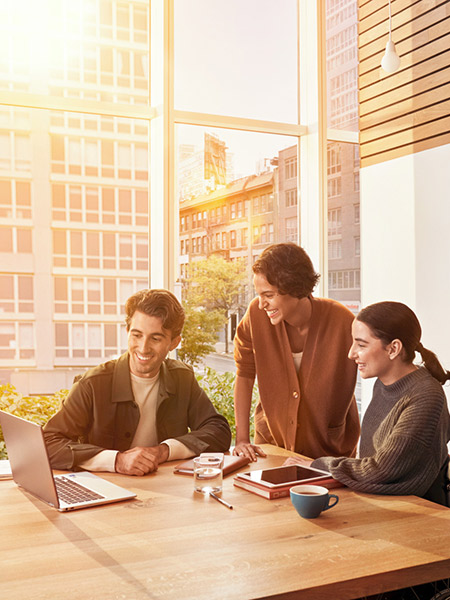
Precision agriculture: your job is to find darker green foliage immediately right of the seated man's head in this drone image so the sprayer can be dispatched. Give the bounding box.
[178,301,224,366]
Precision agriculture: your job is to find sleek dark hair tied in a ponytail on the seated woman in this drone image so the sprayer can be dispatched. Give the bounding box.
[356,301,450,385]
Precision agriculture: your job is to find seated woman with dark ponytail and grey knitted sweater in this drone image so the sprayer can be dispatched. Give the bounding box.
[297,302,450,506]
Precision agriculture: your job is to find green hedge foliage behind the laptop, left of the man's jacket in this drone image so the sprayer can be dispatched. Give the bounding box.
[0,383,69,459]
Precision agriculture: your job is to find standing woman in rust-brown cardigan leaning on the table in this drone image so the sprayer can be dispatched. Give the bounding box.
[234,243,360,460]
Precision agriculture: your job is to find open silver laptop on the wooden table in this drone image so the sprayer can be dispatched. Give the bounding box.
[0,410,136,511]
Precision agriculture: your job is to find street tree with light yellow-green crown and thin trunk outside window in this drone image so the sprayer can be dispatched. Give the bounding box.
[183,255,246,352]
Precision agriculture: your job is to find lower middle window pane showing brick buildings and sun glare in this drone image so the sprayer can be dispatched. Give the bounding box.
[177,126,300,364]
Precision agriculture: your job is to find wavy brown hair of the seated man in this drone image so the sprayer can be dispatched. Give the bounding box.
[125,290,184,339]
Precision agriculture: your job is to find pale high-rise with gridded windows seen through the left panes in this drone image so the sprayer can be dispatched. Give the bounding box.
[0,1,149,394]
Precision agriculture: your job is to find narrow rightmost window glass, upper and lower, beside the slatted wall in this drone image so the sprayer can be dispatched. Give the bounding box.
[326,0,361,405]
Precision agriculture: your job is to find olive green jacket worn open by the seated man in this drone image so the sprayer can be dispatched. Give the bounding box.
[44,352,231,470]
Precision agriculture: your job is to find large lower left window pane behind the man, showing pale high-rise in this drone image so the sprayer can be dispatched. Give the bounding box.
[0,107,149,393]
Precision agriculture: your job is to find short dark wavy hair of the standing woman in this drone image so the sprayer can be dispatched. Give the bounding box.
[253,242,320,298]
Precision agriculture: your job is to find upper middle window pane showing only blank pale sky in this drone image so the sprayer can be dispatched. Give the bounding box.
[175,0,298,123]
